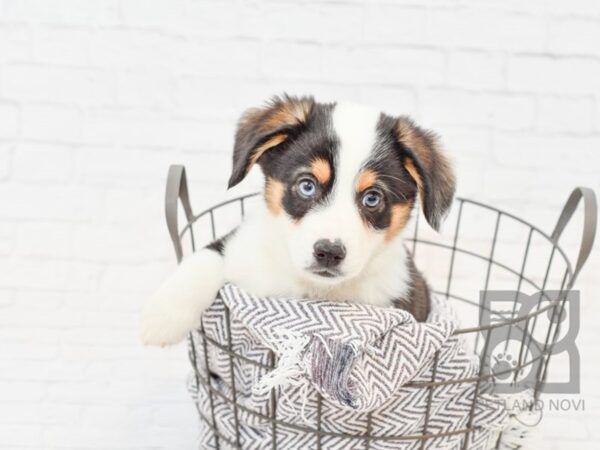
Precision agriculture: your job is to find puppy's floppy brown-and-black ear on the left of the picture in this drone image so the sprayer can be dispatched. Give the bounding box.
[228,94,314,188]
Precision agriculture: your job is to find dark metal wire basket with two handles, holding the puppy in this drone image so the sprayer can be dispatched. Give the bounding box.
[166,165,597,449]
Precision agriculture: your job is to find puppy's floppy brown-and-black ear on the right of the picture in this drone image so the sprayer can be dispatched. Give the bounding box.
[395,117,456,230]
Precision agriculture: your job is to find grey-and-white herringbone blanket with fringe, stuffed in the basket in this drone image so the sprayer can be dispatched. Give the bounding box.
[189,285,520,450]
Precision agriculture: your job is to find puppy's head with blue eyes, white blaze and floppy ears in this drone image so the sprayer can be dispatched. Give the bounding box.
[229,96,455,285]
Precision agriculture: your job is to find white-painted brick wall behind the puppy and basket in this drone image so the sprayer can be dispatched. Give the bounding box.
[0,0,600,450]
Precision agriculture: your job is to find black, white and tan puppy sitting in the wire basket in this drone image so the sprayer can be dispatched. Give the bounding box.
[142,96,455,345]
